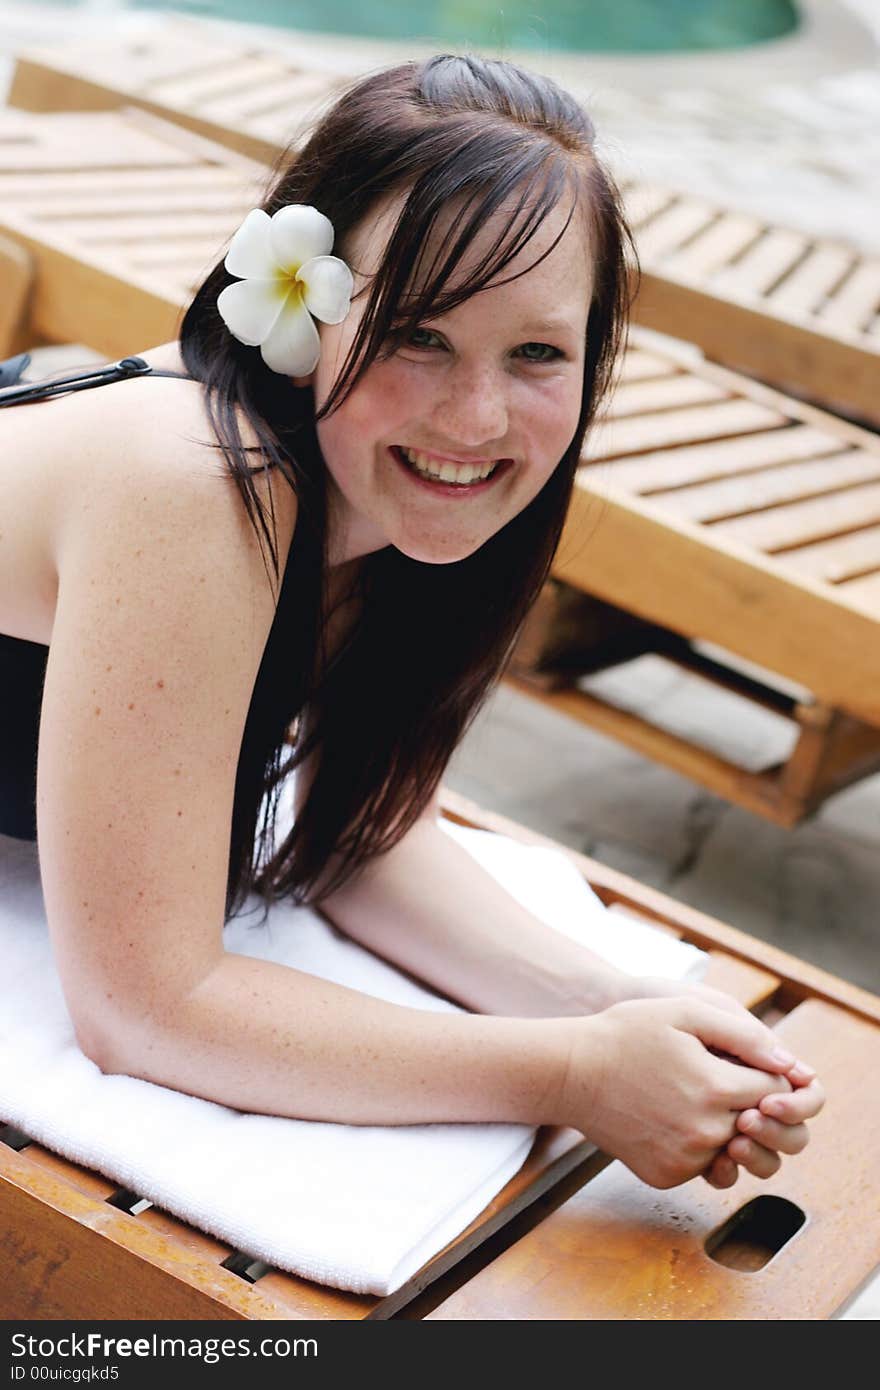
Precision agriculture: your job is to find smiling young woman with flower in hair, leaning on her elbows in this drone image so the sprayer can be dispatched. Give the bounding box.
[0,57,822,1186]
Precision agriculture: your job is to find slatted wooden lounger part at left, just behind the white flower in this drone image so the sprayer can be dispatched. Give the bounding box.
[0,107,267,357]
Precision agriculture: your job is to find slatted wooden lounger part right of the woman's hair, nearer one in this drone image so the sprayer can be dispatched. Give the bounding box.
[513,331,880,826]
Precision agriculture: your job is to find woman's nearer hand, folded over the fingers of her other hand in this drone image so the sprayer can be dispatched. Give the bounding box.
[560,998,799,1187]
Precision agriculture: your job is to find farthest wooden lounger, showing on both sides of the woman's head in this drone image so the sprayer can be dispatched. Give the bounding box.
[10,40,880,424]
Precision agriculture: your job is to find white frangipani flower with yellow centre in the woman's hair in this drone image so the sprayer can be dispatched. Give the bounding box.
[217,203,353,377]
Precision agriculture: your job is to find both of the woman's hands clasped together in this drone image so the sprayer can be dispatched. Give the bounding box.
[566,979,824,1187]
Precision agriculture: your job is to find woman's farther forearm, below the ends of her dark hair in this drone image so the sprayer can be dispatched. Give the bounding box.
[320,819,627,1017]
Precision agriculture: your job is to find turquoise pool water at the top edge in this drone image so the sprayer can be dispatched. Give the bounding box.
[68,0,798,53]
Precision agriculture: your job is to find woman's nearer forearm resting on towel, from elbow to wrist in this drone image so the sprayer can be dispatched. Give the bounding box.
[95,954,570,1125]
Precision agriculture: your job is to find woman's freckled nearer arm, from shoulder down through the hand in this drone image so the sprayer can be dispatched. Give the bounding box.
[30,382,817,1184]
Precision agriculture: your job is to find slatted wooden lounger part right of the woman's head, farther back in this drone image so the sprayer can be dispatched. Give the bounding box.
[624,182,880,425]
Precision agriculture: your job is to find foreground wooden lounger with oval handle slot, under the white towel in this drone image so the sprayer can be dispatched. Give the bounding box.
[0,792,880,1321]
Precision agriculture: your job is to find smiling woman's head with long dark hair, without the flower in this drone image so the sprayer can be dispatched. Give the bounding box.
[181,58,628,895]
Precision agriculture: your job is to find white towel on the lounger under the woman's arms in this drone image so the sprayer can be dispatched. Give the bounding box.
[0,821,706,1294]
